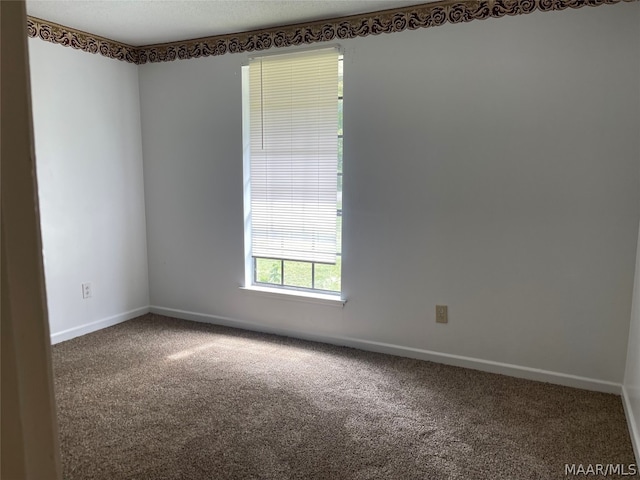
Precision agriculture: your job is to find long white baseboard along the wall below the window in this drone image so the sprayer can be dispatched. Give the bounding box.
[149,305,622,395]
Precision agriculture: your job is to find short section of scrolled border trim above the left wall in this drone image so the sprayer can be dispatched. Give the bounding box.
[27,17,140,64]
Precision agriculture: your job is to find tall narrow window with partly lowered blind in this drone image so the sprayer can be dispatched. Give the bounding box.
[243,48,343,294]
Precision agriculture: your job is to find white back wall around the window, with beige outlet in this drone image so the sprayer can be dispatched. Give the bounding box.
[140,3,640,384]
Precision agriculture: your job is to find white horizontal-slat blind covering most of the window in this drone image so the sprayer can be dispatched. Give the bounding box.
[249,48,338,263]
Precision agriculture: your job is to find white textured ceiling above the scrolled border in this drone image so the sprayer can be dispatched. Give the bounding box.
[27,0,428,46]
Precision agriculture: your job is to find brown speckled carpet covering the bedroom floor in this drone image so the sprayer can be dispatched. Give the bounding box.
[53,314,638,480]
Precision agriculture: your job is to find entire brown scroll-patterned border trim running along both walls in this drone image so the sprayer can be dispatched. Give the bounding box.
[27,0,638,65]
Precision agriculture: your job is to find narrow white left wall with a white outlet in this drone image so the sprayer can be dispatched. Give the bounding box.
[29,39,149,341]
